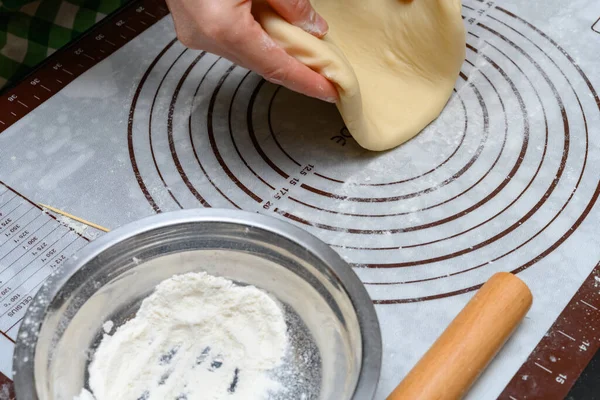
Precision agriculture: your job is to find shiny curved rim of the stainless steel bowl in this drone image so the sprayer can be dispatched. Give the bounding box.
[13,208,382,400]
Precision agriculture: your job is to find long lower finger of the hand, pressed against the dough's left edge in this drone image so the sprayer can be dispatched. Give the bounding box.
[236,28,338,103]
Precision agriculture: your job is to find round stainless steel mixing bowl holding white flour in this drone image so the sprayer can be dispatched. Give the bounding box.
[14,209,381,400]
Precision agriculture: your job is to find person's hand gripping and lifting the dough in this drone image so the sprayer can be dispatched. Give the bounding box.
[167,0,338,103]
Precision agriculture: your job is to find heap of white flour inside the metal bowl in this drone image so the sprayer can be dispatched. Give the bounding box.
[74,273,288,400]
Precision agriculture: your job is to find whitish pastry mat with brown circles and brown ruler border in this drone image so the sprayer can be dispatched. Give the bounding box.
[0,0,600,400]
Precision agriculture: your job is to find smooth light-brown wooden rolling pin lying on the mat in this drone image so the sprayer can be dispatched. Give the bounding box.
[387,272,532,400]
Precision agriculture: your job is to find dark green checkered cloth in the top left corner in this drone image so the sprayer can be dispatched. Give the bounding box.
[0,0,128,89]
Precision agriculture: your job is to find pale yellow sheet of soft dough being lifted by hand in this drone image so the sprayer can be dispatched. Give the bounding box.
[254,0,465,151]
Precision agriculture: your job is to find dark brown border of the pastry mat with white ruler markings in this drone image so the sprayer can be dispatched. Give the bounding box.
[0,0,600,400]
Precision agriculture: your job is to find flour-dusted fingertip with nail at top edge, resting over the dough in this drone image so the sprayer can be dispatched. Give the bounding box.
[267,0,329,37]
